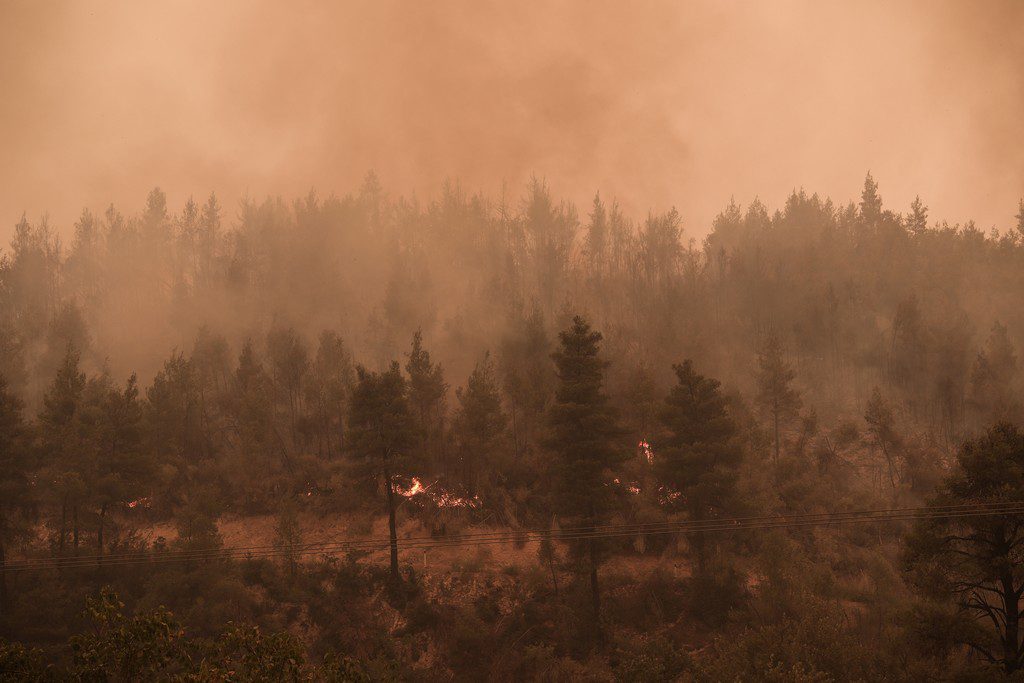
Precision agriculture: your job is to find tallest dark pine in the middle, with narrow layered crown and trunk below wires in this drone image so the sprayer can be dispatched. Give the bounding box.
[546,315,626,642]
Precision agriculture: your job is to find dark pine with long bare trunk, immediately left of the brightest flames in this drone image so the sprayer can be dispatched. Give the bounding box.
[348,362,415,583]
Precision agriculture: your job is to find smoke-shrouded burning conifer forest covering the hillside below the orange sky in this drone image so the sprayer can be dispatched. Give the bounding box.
[0,173,1024,683]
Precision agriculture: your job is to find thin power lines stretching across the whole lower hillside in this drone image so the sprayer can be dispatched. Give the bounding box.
[3,502,1024,571]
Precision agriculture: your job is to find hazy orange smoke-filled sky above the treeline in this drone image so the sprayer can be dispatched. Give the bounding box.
[0,0,1024,237]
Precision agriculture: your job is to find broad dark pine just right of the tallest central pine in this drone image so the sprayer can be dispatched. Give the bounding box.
[654,360,742,571]
